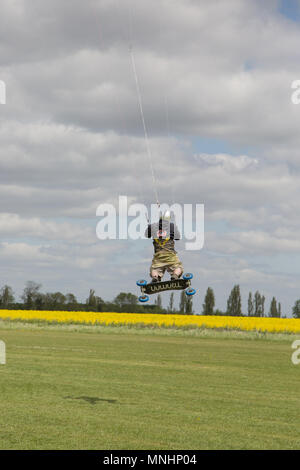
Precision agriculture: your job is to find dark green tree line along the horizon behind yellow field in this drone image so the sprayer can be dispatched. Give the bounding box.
[0,281,300,318]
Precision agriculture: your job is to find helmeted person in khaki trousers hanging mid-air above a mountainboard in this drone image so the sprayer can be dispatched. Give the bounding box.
[145,211,183,282]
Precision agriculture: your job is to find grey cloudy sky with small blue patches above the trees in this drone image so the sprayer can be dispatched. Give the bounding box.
[0,0,300,316]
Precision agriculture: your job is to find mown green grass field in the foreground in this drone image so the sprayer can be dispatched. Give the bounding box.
[0,322,300,450]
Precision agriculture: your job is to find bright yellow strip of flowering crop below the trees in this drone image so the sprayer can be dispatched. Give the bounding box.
[0,310,300,333]
